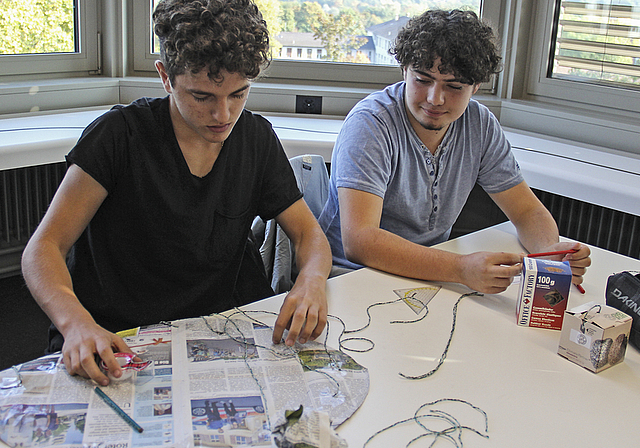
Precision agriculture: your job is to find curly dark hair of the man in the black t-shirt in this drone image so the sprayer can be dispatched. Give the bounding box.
[153,0,270,83]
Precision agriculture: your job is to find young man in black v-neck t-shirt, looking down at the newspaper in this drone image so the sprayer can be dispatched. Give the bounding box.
[23,0,331,385]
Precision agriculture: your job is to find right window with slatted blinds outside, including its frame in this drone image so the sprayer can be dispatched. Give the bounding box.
[527,0,640,112]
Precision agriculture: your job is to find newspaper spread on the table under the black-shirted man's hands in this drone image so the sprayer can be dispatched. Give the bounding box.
[0,315,369,448]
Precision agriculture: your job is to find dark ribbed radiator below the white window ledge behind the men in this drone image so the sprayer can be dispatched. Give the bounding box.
[0,162,640,277]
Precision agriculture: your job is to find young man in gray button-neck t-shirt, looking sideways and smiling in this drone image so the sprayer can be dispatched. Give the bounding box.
[319,10,591,293]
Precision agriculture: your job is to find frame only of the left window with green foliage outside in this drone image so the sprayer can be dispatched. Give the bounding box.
[0,0,101,76]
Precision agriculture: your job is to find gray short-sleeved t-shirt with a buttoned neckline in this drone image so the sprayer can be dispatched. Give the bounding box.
[318,82,524,269]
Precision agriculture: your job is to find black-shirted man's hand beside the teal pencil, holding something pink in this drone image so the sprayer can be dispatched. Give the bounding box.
[62,323,132,386]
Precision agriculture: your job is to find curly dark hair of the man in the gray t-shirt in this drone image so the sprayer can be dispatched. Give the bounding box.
[389,9,502,84]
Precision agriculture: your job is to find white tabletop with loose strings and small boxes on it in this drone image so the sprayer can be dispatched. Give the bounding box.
[248,223,640,448]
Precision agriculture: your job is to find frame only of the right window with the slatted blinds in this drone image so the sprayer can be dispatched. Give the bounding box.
[526,0,640,113]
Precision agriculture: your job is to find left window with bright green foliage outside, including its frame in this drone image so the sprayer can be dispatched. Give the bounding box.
[0,0,100,75]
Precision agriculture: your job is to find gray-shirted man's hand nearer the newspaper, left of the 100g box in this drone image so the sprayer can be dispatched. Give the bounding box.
[460,252,522,294]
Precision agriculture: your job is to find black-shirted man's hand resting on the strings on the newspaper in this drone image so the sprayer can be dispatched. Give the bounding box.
[273,274,327,347]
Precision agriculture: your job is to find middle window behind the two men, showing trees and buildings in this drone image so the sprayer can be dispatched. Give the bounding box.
[130,0,490,86]
